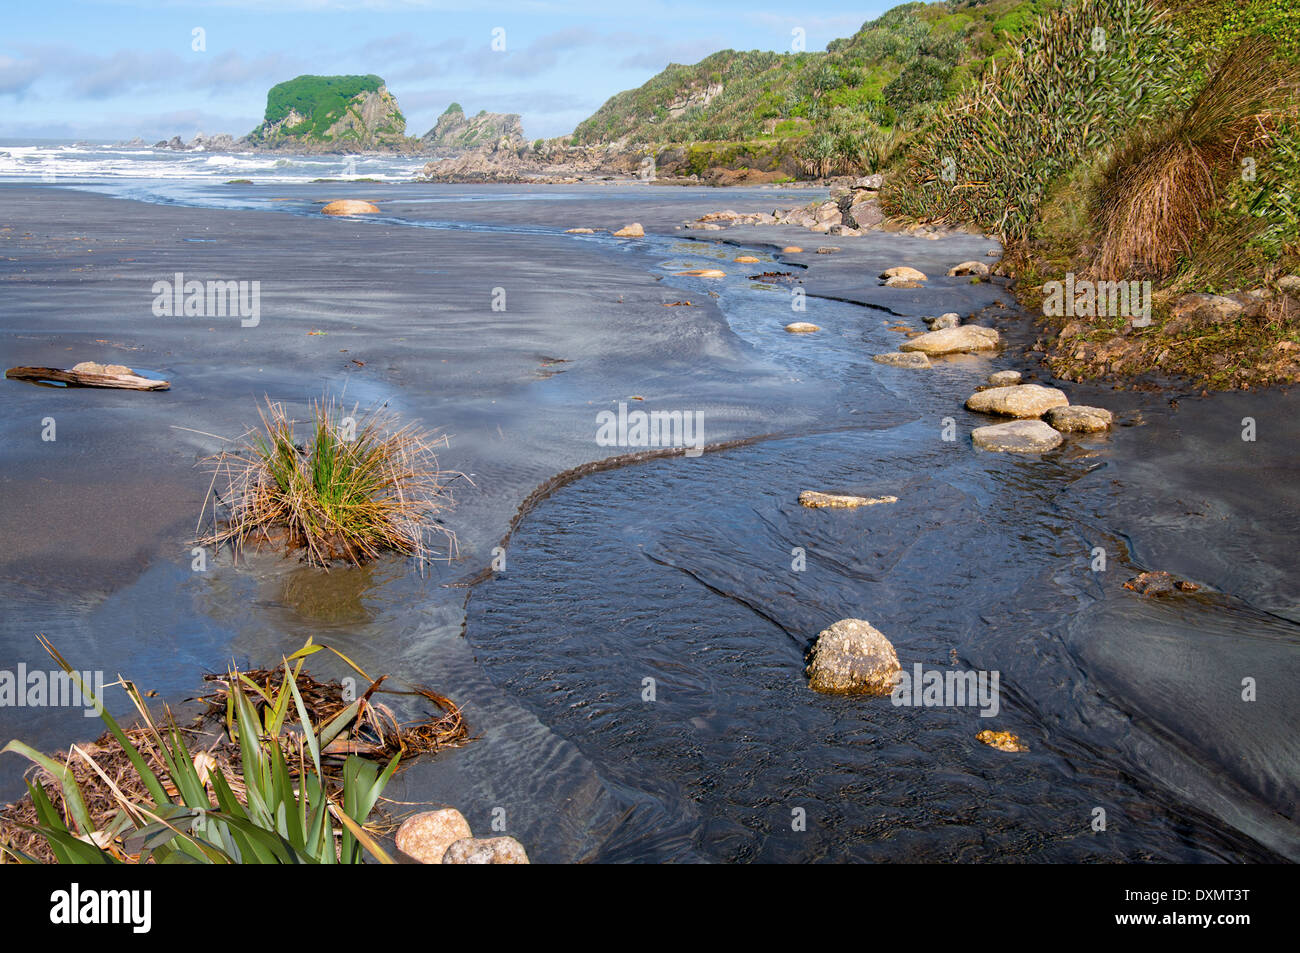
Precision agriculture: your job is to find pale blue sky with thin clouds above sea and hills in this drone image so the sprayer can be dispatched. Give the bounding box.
[0,0,898,142]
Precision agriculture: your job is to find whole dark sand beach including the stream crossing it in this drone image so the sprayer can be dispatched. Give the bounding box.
[0,185,1300,862]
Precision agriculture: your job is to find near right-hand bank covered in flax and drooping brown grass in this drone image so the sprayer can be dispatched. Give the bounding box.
[881,0,1300,387]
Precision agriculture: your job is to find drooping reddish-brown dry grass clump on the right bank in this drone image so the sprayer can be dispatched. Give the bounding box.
[1093,38,1300,280]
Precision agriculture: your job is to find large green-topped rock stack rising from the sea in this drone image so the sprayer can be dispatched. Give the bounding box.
[248,74,408,148]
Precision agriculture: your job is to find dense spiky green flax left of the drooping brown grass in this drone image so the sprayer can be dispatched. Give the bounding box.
[883,0,1190,241]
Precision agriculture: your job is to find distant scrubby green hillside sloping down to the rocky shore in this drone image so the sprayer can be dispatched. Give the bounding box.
[572,0,1061,176]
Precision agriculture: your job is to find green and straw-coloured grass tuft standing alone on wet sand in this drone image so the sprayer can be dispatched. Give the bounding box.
[199,399,460,566]
